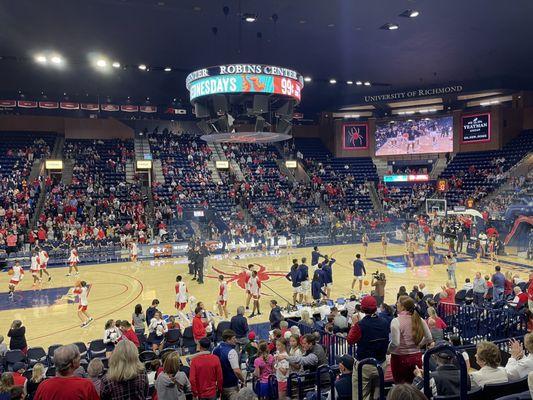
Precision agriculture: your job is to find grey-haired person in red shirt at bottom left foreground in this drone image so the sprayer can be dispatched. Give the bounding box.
[34,344,100,400]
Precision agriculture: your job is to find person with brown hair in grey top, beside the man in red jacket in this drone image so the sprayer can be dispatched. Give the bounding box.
[155,352,191,400]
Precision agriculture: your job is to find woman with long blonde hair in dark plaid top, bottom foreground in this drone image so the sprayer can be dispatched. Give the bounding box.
[100,340,148,400]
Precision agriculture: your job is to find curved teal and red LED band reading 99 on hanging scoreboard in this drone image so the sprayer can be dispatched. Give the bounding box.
[189,74,302,101]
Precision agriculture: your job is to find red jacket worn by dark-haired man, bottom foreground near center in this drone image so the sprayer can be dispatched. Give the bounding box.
[189,354,223,398]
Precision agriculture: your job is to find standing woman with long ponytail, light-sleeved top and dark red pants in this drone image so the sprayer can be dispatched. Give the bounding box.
[389,296,433,383]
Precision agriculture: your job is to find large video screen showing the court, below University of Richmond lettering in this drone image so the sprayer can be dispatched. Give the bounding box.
[376,116,453,156]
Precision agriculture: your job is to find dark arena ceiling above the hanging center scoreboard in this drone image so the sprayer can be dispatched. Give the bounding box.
[0,0,533,112]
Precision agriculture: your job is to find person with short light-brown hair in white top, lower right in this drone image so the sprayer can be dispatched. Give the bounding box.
[470,341,509,387]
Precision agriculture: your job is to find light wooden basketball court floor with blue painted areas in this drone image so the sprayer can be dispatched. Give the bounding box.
[0,243,533,347]
